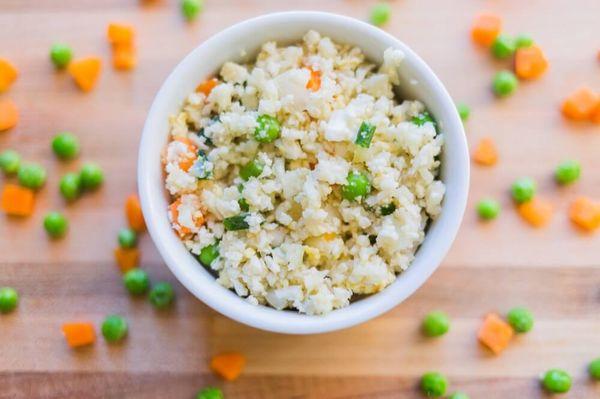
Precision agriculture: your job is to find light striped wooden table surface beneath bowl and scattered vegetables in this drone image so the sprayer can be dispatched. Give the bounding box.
[0,0,600,399]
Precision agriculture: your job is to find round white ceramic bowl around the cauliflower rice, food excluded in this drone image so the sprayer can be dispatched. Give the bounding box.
[138,12,469,334]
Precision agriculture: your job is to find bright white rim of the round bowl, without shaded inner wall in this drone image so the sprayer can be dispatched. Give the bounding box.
[137,11,470,334]
